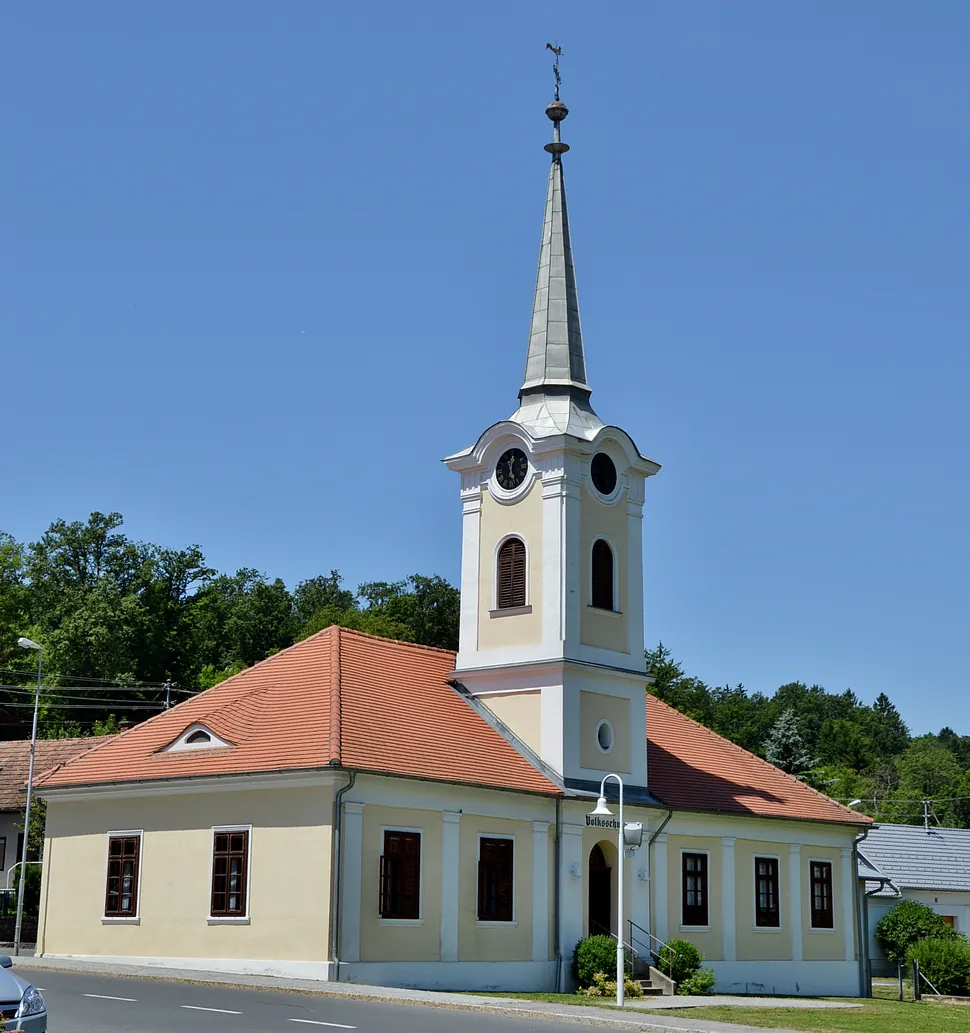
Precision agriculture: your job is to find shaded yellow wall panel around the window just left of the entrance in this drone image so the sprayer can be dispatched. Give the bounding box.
[458,814,532,962]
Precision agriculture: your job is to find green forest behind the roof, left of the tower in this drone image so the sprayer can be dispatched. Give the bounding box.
[0,512,459,739]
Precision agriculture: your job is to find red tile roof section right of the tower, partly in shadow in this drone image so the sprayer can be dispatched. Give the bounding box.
[647,694,872,825]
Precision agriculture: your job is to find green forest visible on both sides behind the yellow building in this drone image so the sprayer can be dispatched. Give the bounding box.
[0,512,970,827]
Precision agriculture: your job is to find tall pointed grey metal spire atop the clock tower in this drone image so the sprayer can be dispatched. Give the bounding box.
[519,97,590,404]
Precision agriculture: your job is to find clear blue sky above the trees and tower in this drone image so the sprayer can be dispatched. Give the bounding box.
[7,6,970,733]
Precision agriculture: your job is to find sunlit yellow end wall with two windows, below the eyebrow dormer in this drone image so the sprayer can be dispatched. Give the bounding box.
[38,787,333,961]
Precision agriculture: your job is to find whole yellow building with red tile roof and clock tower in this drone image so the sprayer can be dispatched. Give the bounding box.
[30,92,871,995]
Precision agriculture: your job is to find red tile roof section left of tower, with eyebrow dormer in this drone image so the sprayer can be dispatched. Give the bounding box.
[39,627,558,793]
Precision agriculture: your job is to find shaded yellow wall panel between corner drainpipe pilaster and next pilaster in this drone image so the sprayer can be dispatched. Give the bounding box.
[361,804,441,962]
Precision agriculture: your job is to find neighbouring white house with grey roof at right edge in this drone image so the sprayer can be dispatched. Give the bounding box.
[858,824,970,975]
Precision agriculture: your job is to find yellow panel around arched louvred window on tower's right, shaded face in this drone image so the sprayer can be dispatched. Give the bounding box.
[580,483,630,653]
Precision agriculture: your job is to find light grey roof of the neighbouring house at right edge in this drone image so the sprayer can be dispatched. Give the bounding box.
[859,824,970,896]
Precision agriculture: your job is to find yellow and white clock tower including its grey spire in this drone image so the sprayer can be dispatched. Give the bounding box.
[444,89,660,788]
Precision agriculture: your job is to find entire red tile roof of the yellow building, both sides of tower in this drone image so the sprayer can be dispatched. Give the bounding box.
[38,627,868,824]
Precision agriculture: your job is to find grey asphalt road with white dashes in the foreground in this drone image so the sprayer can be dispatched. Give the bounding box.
[34,969,619,1033]
